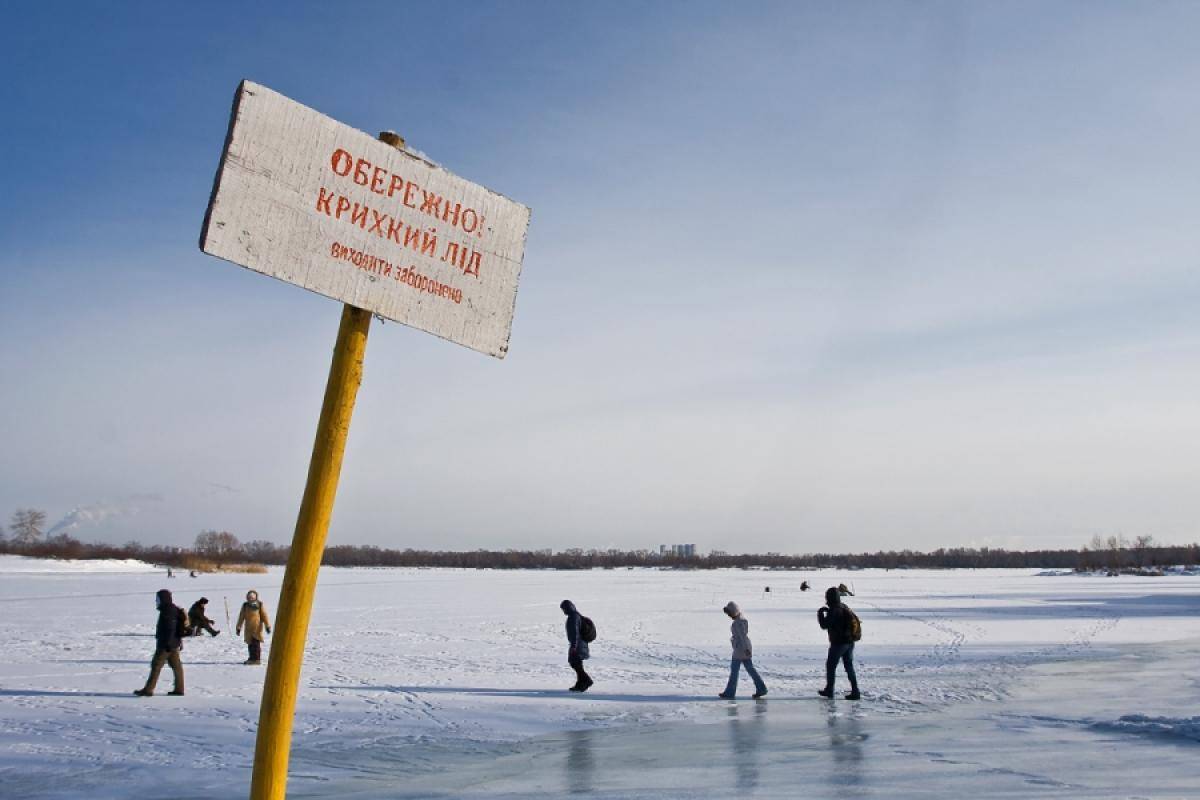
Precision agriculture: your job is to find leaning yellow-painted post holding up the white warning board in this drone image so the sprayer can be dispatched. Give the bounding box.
[250,132,404,800]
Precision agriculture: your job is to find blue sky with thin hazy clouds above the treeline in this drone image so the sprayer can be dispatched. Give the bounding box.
[0,2,1200,552]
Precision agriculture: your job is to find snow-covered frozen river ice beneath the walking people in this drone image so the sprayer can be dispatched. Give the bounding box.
[0,558,1200,800]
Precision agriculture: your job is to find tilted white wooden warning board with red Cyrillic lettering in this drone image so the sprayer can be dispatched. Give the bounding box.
[200,80,529,359]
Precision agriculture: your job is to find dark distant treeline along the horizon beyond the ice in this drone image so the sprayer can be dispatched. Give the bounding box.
[0,517,1200,570]
